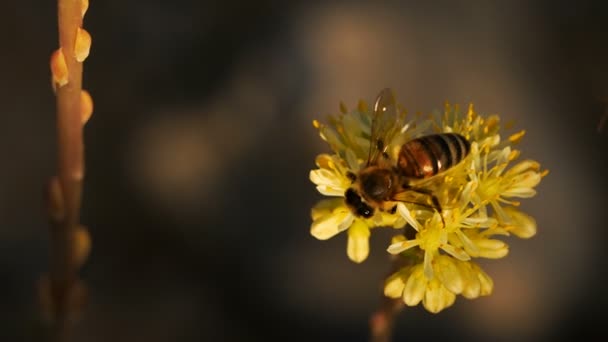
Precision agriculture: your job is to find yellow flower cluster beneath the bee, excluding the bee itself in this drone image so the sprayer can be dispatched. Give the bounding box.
[310,97,547,313]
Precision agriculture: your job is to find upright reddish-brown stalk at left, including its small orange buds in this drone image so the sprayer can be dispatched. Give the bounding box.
[40,0,92,341]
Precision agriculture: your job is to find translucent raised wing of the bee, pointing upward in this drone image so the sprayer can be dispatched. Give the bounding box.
[367,88,401,166]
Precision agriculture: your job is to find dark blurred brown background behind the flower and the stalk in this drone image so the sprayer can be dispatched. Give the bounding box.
[0,0,608,342]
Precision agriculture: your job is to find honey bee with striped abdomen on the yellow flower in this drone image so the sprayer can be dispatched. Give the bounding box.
[344,88,471,221]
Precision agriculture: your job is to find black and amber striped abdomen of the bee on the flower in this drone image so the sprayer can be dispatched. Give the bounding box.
[398,133,471,178]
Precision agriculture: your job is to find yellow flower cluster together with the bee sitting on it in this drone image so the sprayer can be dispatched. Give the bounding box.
[310,89,547,330]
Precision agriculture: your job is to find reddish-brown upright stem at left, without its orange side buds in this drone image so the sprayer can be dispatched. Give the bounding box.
[49,0,84,341]
